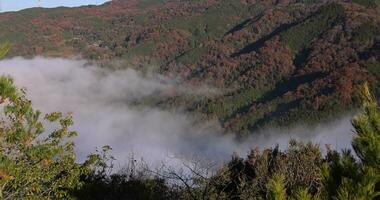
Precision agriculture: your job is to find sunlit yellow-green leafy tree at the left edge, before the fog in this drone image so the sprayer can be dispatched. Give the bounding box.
[0,46,101,199]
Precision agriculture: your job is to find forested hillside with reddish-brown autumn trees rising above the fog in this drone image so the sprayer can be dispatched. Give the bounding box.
[0,0,380,134]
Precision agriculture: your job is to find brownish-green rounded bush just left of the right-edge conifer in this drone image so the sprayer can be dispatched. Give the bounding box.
[208,141,322,199]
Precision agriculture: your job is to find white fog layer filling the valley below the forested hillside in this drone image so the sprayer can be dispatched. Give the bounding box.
[0,57,353,165]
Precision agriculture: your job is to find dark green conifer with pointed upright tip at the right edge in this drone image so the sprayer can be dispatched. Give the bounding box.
[322,84,380,200]
